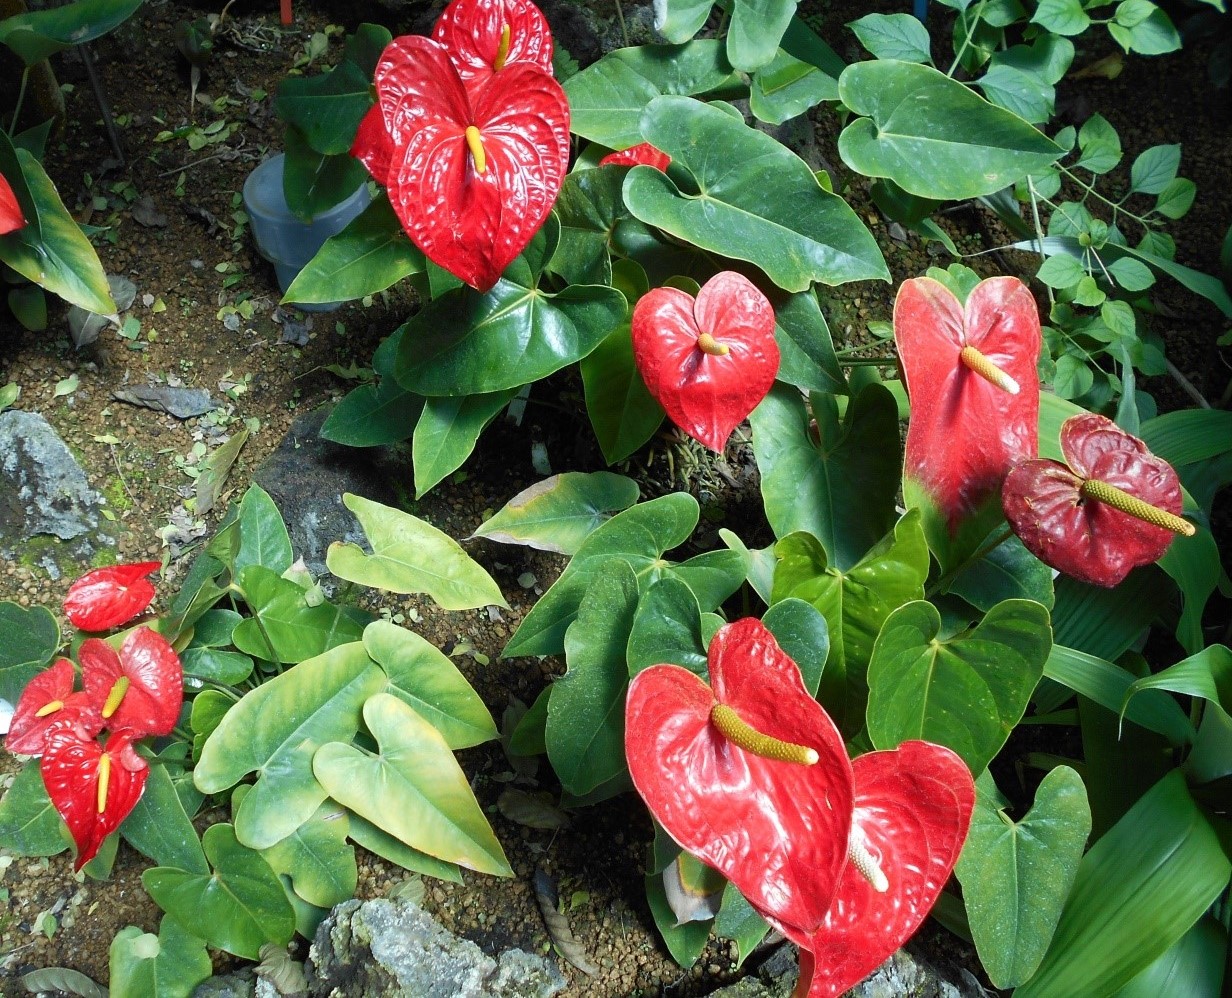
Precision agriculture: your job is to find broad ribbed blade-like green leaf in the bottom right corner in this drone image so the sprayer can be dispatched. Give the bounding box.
[1015,770,1232,998]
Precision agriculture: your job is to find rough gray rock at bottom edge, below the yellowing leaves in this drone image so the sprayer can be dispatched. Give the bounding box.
[306,898,568,998]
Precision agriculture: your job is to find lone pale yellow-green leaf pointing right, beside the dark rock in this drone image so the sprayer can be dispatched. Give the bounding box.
[325,493,508,610]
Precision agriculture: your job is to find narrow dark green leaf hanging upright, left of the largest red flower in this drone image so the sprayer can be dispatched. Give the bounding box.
[547,559,645,797]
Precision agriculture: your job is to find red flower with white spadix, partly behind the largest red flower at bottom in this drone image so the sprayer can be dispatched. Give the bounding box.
[776,742,976,998]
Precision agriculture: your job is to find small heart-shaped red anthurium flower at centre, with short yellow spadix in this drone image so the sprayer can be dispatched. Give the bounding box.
[633,271,779,451]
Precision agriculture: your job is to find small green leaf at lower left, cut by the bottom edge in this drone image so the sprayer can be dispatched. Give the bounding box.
[107,916,213,998]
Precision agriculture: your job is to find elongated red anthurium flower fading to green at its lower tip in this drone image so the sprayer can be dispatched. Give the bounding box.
[894,277,1041,535]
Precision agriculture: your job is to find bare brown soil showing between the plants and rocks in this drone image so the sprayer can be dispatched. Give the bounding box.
[0,0,1232,998]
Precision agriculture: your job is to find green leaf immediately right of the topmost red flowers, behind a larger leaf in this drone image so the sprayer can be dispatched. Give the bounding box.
[564,40,739,152]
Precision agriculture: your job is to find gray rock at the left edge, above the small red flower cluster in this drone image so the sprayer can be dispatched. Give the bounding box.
[0,409,115,578]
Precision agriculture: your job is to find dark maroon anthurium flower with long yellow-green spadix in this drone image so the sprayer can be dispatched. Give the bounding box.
[1002,413,1195,586]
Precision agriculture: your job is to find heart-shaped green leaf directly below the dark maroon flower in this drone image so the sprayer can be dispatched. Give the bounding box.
[867,600,1052,773]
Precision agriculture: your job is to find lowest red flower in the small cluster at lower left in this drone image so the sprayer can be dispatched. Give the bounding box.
[39,721,149,870]
